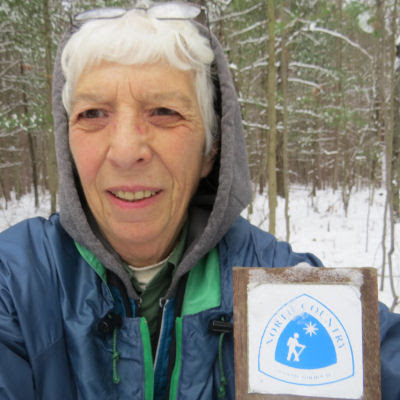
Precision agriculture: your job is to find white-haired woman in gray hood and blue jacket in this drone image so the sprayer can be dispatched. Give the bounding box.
[0,3,400,400]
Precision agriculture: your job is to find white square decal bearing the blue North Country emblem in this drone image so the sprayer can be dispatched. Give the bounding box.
[248,284,363,399]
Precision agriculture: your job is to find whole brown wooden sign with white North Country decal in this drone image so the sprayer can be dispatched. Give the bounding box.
[233,264,381,400]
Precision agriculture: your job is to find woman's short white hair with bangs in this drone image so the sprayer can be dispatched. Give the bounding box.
[61,9,216,154]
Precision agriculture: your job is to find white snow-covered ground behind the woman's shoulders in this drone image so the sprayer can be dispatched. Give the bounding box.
[0,186,400,311]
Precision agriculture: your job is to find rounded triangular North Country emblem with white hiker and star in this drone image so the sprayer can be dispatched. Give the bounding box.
[258,294,354,386]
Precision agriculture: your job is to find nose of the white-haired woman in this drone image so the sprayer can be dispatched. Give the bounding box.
[107,114,152,169]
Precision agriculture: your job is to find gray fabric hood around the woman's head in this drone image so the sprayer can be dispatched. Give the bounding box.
[53,21,251,299]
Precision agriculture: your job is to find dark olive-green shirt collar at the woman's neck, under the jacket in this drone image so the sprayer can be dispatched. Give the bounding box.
[125,223,188,358]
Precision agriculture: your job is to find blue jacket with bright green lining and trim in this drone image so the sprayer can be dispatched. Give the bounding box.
[0,215,400,400]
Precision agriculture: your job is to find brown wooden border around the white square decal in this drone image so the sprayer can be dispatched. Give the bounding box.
[233,267,381,400]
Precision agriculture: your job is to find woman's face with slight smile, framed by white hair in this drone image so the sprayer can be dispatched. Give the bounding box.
[69,62,216,266]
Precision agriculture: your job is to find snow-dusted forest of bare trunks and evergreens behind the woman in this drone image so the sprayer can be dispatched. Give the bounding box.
[0,0,400,307]
